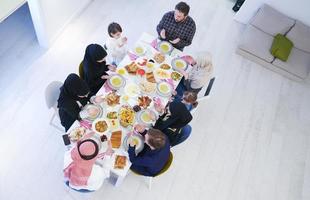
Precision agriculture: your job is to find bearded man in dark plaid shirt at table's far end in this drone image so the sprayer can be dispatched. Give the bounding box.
[157,2,196,51]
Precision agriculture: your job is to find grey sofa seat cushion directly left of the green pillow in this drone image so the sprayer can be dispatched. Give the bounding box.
[239,25,273,63]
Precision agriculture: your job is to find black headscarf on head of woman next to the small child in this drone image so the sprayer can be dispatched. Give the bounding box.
[83,44,108,69]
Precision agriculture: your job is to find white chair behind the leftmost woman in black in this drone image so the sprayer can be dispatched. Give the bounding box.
[45,81,65,132]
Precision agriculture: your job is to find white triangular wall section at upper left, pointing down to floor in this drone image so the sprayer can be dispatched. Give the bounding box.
[28,0,91,47]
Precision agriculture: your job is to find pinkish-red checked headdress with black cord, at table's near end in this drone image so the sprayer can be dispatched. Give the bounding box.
[64,134,98,186]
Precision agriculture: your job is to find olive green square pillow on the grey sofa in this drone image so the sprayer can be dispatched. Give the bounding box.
[270,33,293,62]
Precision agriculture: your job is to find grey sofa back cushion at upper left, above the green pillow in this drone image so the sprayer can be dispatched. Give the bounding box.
[250,4,295,36]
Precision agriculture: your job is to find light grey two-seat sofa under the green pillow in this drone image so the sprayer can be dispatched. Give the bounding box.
[237,4,310,81]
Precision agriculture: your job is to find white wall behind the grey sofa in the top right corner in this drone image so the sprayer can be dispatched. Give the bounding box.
[235,0,310,26]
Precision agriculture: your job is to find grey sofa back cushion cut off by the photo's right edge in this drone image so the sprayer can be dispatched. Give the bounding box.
[286,20,310,53]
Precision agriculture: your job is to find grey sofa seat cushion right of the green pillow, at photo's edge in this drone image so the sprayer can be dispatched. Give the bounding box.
[272,48,310,79]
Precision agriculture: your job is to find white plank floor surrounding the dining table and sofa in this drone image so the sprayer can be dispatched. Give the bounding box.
[0,0,310,200]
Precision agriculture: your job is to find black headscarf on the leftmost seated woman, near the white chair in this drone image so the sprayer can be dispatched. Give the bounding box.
[60,73,89,100]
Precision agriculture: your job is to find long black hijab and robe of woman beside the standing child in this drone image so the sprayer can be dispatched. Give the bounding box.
[83,44,109,95]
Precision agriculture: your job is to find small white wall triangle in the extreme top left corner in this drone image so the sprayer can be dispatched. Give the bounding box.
[0,0,26,22]
